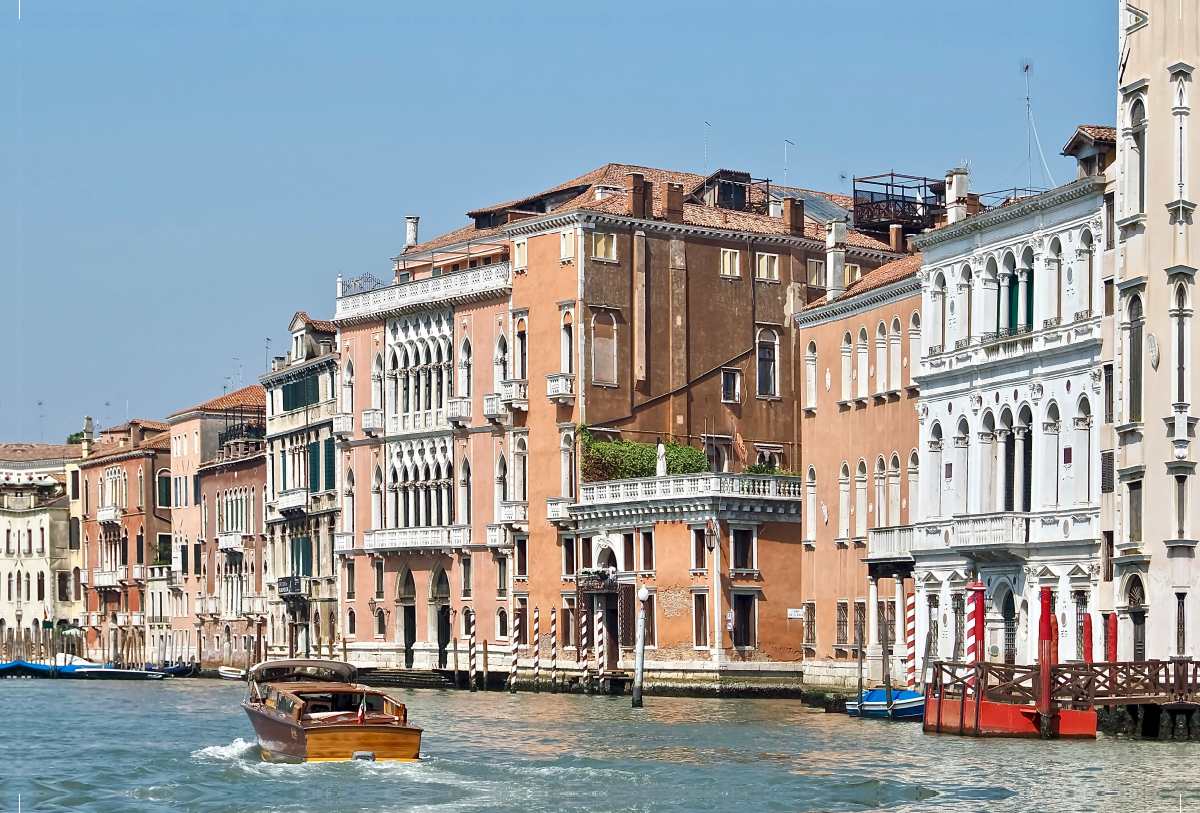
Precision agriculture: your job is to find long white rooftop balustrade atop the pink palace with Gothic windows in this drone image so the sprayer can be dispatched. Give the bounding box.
[334,260,512,324]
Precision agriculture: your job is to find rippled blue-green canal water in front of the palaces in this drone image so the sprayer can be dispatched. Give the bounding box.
[0,680,1200,813]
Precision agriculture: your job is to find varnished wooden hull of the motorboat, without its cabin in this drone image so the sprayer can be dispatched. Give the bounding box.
[242,704,421,763]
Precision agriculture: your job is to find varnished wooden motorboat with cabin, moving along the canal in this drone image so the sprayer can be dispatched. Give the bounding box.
[241,660,421,763]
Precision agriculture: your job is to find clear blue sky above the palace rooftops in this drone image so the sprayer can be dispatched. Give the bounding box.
[0,0,1117,442]
